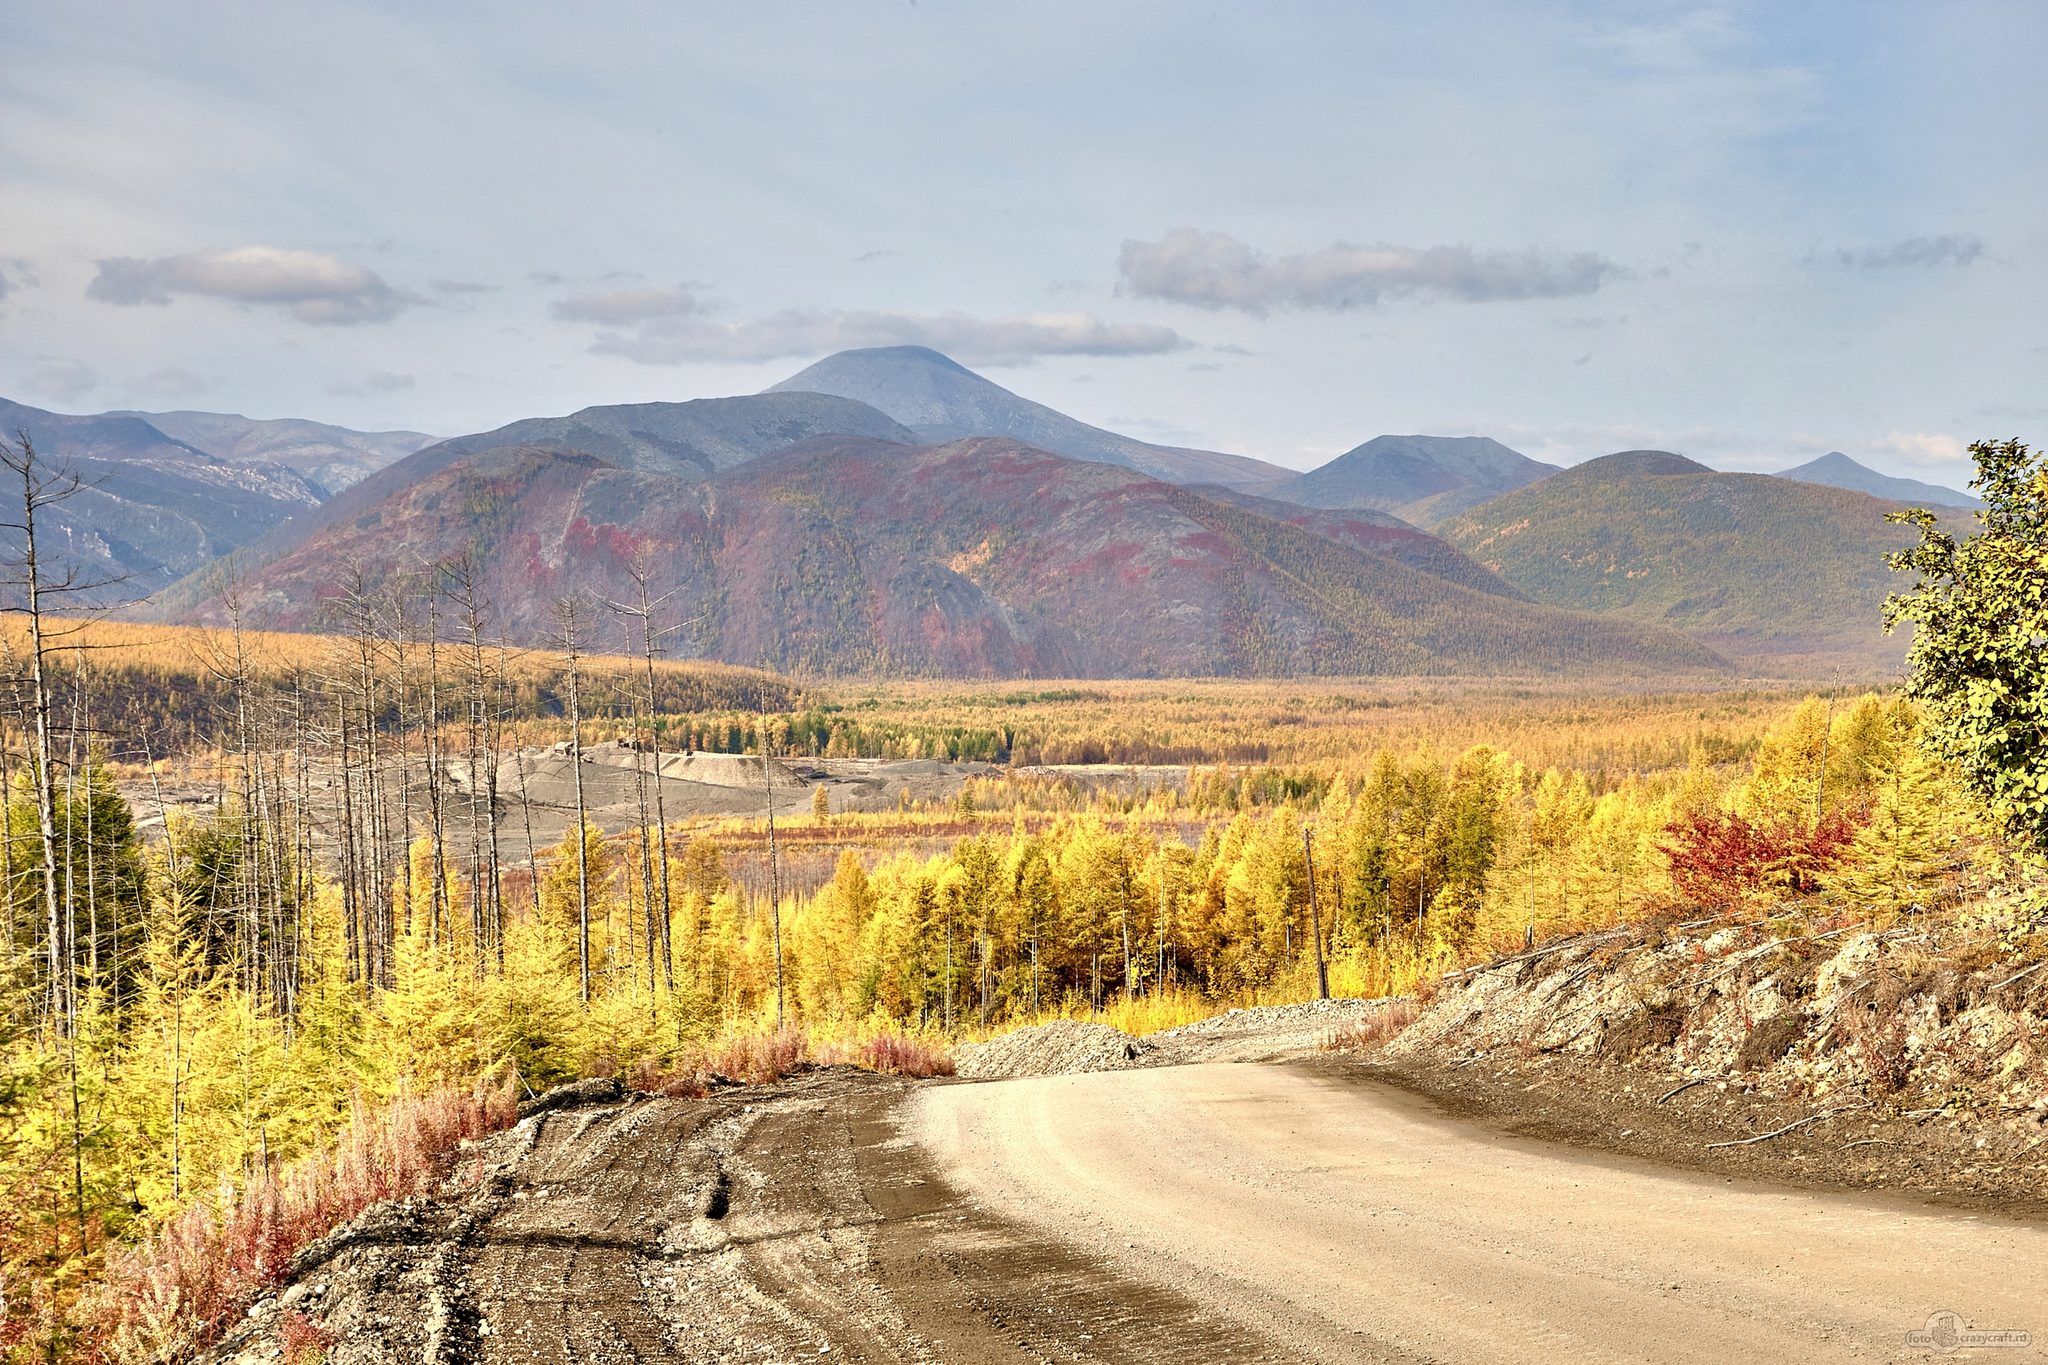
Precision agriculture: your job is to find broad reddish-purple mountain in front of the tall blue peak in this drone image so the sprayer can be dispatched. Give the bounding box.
[186,436,1724,677]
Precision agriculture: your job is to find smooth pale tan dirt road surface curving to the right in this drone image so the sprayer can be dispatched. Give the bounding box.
[905,1064,2048,1363]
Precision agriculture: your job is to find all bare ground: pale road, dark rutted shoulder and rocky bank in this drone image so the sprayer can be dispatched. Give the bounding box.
[207,919,2048,1365]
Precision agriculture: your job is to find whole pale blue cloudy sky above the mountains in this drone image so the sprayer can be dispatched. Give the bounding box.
[0,0,2048,487]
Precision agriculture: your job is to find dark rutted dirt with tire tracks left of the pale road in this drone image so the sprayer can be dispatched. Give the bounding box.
[239,1068,1290,1365]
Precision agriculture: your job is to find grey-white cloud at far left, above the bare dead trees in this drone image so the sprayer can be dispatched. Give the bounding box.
[86,246,422,327]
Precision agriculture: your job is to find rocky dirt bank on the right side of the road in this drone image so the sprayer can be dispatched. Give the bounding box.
[1368,915,2048,1209]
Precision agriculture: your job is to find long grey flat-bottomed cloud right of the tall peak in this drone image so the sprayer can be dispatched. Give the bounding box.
[1116,227,1620,313]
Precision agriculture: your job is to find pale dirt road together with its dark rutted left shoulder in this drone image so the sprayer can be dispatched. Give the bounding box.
[216,1047,2048,1365]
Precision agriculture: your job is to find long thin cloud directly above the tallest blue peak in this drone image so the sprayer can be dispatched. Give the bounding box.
[592,311,1192,366]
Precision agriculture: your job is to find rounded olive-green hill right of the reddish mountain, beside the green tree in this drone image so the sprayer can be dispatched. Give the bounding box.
[1440,450,1962,665]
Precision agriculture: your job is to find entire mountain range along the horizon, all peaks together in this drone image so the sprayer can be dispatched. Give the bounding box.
[0,346,1964,675]
